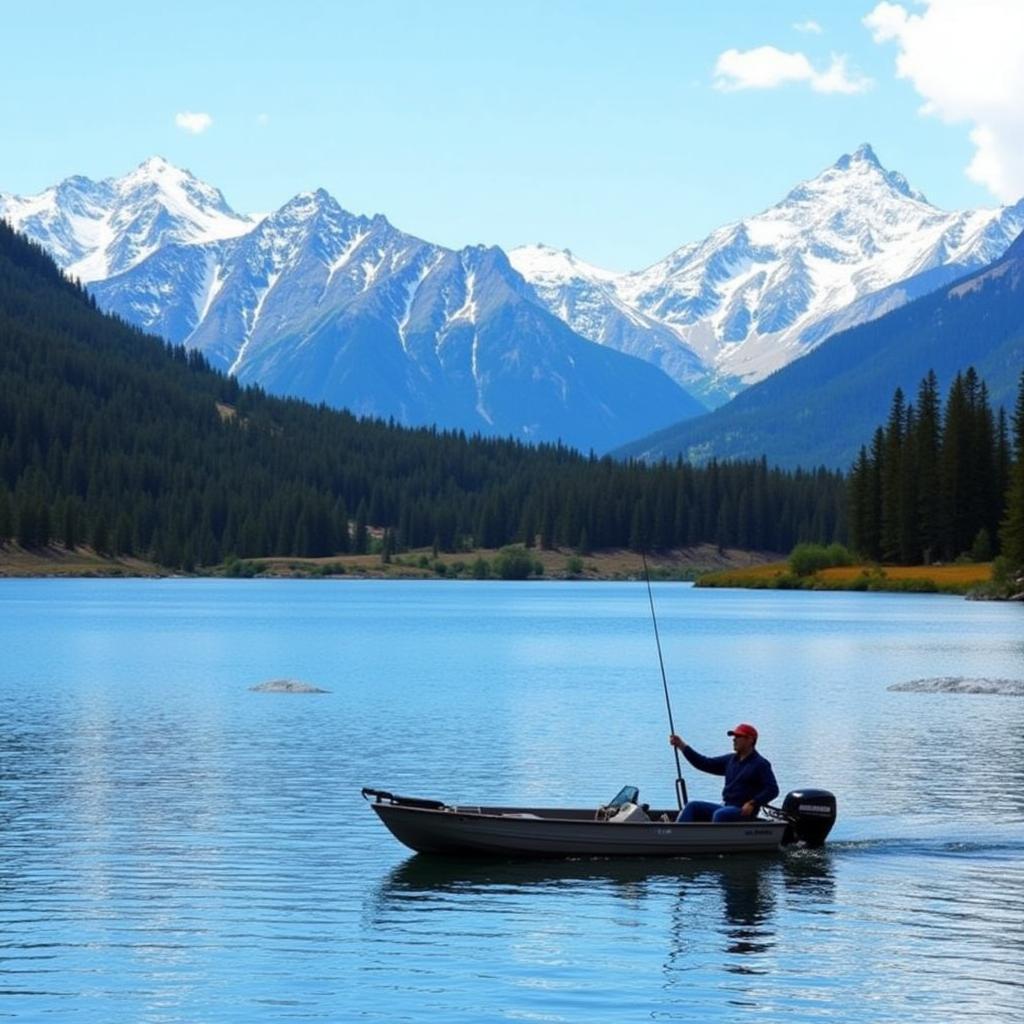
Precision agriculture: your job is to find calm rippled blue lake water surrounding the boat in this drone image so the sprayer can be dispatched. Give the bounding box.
[0,581,1024,1024]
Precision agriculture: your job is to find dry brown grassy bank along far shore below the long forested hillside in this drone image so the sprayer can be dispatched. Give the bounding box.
[0,544,778,580]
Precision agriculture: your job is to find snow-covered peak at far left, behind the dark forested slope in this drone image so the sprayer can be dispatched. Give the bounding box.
[0,157,255,284]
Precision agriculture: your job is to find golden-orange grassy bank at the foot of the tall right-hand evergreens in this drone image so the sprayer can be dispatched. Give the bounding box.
[697,562,992,594]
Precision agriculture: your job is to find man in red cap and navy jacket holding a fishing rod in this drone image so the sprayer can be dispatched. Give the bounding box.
[669,722,778,823]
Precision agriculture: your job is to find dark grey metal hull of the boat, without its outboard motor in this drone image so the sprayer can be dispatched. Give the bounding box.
[371,800,786,857]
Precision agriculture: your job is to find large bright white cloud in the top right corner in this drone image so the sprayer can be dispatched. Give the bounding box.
[864,0,1024,203]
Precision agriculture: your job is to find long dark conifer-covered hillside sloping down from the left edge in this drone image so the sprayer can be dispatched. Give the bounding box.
[0,223,846,568]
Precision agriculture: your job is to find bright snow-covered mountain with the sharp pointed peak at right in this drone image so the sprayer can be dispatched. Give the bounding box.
[509,144,1024,398]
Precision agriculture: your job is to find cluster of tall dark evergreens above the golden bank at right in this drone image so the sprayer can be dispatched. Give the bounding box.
[849,368,1024,568]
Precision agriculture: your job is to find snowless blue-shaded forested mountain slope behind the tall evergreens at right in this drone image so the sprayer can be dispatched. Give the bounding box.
[616,226,1024,470]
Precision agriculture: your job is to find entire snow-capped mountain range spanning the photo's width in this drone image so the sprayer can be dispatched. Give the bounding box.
[6,145,1024,449]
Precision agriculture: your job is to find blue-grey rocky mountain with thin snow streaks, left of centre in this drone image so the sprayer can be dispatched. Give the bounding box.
[91,190,703,451]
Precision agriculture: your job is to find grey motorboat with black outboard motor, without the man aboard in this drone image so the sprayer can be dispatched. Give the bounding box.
[361,786,836,857]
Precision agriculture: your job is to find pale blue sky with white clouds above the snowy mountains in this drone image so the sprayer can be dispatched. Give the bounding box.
[0,0,1024,269]
